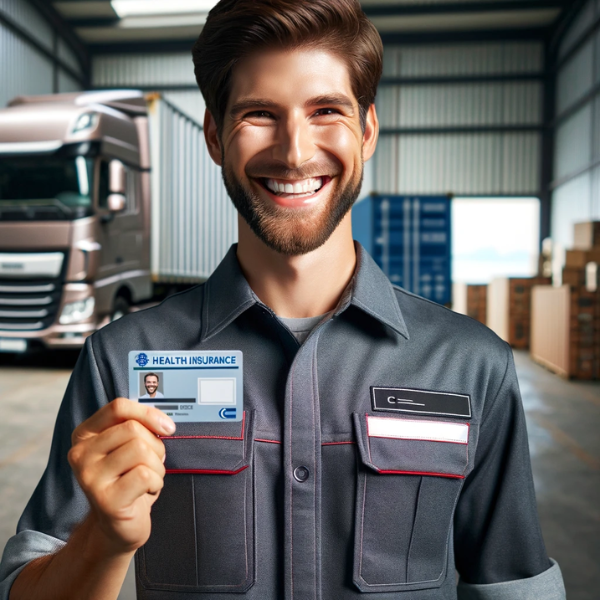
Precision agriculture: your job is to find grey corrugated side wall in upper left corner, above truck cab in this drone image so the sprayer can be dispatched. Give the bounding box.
[0,0,82,108]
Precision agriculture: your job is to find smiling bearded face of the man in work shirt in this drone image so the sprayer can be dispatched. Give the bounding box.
[204,48,376,256]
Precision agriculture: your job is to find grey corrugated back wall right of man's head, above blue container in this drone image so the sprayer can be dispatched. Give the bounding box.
[373,42,543,195]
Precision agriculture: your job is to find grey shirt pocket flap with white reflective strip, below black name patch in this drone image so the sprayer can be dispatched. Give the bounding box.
[354,413,469,479]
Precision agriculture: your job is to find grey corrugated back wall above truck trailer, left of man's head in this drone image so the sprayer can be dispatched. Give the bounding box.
[92,52,204,123]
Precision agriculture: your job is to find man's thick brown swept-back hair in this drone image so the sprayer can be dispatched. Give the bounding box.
[192,0,383,131]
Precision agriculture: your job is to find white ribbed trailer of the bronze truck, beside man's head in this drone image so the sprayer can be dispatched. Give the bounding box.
[151,99,238,281]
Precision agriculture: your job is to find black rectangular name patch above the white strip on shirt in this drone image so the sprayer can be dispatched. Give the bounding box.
[371,386,471,419]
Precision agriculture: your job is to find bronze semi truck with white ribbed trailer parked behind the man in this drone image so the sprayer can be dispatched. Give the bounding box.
[0,90,237,352]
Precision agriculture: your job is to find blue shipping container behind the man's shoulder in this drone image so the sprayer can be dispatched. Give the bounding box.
[352,195,452,304]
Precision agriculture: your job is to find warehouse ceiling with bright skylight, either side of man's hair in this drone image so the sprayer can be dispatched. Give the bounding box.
[52,0,573,51]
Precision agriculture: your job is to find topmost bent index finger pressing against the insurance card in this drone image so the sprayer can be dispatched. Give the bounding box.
[72,398,175,445]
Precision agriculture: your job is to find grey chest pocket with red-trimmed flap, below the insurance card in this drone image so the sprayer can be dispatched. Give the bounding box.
[136,413,255,597]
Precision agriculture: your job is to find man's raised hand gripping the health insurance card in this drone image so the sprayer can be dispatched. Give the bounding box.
[68,398,175,553]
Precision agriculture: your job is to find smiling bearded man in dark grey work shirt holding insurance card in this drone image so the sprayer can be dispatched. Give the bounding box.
[0,0,565,600]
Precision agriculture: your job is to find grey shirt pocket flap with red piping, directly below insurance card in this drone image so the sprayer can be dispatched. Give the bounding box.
[161,411,254,475]
